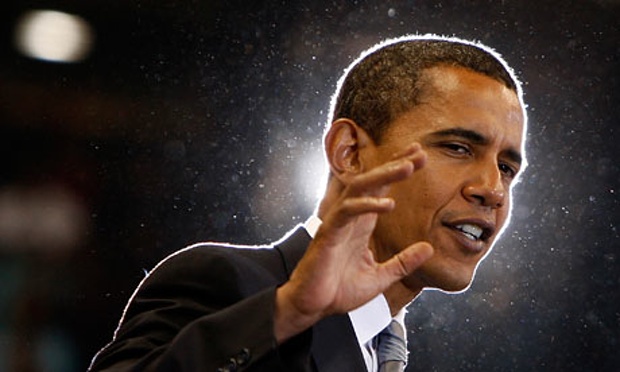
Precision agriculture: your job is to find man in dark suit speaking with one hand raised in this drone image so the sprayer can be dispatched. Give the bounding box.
[91,36,526,372]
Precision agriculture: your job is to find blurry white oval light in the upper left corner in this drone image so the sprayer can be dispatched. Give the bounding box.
[15,10,93,62]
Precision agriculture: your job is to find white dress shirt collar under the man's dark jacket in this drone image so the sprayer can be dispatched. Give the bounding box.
[304,215,407,372]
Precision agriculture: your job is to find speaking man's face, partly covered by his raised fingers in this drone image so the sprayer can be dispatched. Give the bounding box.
[364,66,524,291]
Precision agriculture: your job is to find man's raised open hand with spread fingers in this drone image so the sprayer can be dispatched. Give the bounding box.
[275,145,432,342]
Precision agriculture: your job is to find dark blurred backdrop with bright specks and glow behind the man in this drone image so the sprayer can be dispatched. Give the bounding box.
[0,0,620,371]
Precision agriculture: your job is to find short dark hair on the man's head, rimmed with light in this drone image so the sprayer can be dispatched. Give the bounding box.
[330,35,522,142]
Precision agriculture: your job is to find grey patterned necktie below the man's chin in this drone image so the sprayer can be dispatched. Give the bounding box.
[377,320,407,372]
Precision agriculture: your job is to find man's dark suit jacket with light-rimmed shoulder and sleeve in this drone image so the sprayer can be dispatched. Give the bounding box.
[91,227,366,372]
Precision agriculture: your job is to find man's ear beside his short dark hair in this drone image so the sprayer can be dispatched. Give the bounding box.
[325,118,374,181]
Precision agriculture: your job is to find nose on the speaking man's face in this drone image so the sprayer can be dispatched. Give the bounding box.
[463,165,508,209]
